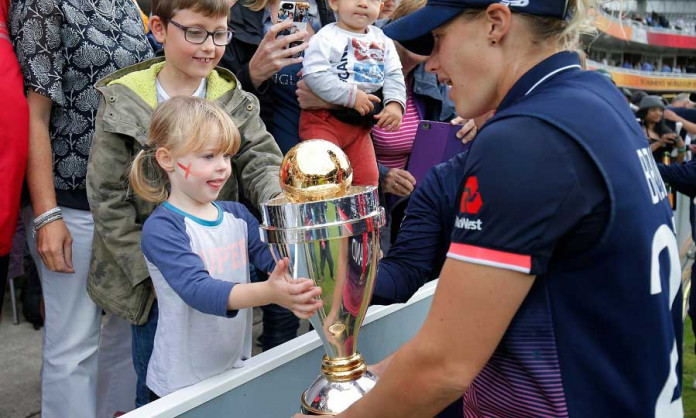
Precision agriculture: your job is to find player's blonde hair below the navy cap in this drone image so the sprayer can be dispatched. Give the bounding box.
[460,0,605,51]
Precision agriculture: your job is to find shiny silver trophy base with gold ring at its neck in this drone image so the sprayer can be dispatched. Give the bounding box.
[300,353,377,415]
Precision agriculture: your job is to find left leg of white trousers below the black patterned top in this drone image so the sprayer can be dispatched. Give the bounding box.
[24,207,101,418]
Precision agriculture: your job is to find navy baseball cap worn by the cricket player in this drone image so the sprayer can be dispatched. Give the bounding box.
[384,0,570,55]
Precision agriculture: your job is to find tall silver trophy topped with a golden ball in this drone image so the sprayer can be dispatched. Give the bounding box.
[261,140,385,415]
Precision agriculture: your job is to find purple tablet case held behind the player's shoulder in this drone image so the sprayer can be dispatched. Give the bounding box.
[406,120,471,184]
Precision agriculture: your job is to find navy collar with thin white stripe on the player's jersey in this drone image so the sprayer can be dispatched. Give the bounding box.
[497,51,582,112]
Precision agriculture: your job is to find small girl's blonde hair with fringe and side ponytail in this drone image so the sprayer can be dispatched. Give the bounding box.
[129,96,241,203]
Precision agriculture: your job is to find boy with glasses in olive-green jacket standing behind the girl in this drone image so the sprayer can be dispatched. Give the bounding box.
[87,0,282,406]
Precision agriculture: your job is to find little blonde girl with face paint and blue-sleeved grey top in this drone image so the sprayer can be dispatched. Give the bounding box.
[130,96,321,399]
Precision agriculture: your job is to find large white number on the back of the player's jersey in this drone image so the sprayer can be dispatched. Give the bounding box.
[650,224,684,418]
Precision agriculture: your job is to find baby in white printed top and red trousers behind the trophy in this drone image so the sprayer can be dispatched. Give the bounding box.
[300,0,406,186]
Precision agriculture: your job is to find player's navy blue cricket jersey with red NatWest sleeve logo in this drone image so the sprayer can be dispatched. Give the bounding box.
[448,52,683,417]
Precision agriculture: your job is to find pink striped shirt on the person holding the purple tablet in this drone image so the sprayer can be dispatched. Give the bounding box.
[372,81,420,169]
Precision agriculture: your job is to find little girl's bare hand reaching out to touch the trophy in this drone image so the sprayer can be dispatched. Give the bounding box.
[268,257,324,319]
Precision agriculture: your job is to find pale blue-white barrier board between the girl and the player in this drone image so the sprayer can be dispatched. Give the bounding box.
[124,281,437,418]
